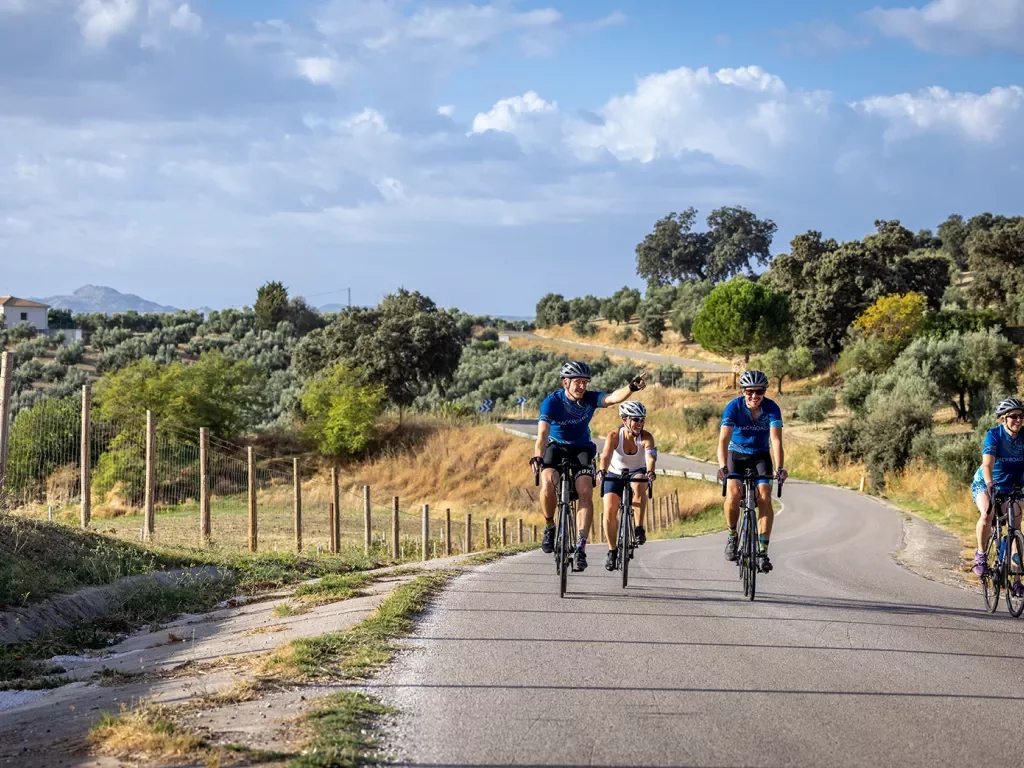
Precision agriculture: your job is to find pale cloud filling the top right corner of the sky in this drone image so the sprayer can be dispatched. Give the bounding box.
[866,0,1024,52]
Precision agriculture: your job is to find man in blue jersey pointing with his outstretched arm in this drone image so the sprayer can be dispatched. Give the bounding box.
[529,360,647,570]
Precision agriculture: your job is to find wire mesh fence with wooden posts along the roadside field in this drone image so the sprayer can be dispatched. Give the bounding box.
[0,378,537,560]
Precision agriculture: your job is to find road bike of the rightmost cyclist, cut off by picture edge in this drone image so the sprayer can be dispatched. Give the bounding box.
[981,486,1024,618]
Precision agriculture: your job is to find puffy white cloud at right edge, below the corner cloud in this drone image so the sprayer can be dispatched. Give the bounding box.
[854,85,1024,143]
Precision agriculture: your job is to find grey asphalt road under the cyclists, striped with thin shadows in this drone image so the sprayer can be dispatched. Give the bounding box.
[370,423,1024,767]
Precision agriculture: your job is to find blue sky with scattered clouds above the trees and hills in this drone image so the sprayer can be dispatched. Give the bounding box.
[0,0,1024,314]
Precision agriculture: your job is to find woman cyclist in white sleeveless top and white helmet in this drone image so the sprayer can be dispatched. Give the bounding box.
[598,400,657,570]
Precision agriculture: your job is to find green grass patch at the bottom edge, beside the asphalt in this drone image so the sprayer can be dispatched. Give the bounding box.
[288,691,395,768]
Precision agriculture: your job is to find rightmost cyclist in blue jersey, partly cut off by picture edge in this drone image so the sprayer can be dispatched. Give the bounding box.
[971,397,1024,597]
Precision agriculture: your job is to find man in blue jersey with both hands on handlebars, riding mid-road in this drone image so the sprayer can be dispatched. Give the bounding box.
[718,370,790,573]
